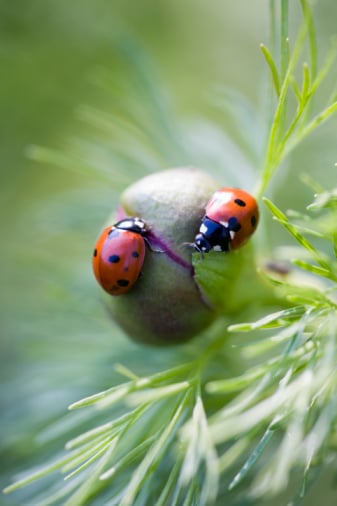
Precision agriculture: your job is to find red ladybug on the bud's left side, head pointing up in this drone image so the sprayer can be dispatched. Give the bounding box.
[92,217,148,295]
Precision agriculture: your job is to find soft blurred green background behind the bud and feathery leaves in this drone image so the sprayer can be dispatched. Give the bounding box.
[0,0,337,504]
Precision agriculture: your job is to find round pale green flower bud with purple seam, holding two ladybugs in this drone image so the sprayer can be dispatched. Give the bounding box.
[103,168,219,345]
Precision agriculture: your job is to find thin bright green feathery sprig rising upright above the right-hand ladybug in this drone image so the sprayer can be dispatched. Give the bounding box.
[257,0,337,197]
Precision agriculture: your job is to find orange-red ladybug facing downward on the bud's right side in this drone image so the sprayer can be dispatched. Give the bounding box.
[193,187,259,253]
